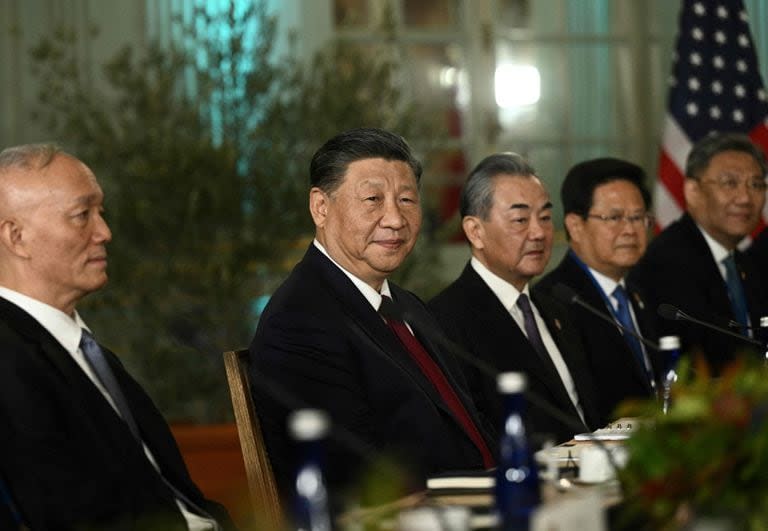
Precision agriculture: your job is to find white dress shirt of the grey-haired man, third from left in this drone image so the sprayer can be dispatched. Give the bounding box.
[470,256,586,424]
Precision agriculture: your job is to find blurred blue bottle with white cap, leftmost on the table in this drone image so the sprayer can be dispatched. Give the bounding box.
[288,409,331,531]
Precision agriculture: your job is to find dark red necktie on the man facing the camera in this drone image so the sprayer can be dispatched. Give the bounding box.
[379,295,495,468]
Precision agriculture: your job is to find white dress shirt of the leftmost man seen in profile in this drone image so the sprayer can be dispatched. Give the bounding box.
[0,286,215,531]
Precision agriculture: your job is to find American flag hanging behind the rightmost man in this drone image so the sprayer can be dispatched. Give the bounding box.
[655,0,768,233]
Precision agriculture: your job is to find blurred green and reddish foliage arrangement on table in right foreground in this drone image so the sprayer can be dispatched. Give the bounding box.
[620,360,768,530]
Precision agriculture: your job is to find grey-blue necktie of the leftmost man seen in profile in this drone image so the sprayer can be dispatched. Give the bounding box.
[80,328,219,529]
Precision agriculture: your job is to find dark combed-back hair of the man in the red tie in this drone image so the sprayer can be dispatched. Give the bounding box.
[309,127,422,193]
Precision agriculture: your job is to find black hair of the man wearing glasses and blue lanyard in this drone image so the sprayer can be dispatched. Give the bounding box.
[560,157,651,219]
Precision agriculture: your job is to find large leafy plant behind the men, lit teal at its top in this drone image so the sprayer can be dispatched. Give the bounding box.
[32,1,448,421]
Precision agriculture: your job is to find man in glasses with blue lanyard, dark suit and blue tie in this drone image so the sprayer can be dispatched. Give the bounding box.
[534,158,661,422]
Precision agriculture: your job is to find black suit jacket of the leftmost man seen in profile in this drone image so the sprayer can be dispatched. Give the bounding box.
[0,298,231,531]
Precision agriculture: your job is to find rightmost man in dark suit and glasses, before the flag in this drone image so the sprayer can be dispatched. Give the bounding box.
[630,133,768,374]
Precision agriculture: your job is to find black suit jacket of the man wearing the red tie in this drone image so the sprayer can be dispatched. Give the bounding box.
[250,245,495,498]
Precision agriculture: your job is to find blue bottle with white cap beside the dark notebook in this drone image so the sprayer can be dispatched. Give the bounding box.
[496,372,541,531]
